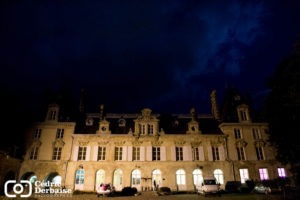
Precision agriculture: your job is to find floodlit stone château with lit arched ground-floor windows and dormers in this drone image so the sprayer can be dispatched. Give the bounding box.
[19,91,289,191]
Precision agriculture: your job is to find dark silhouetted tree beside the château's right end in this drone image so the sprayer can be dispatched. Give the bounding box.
[265,40,300,185]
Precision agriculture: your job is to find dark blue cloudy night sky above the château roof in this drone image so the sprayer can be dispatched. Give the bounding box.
[0,0,300,113]
